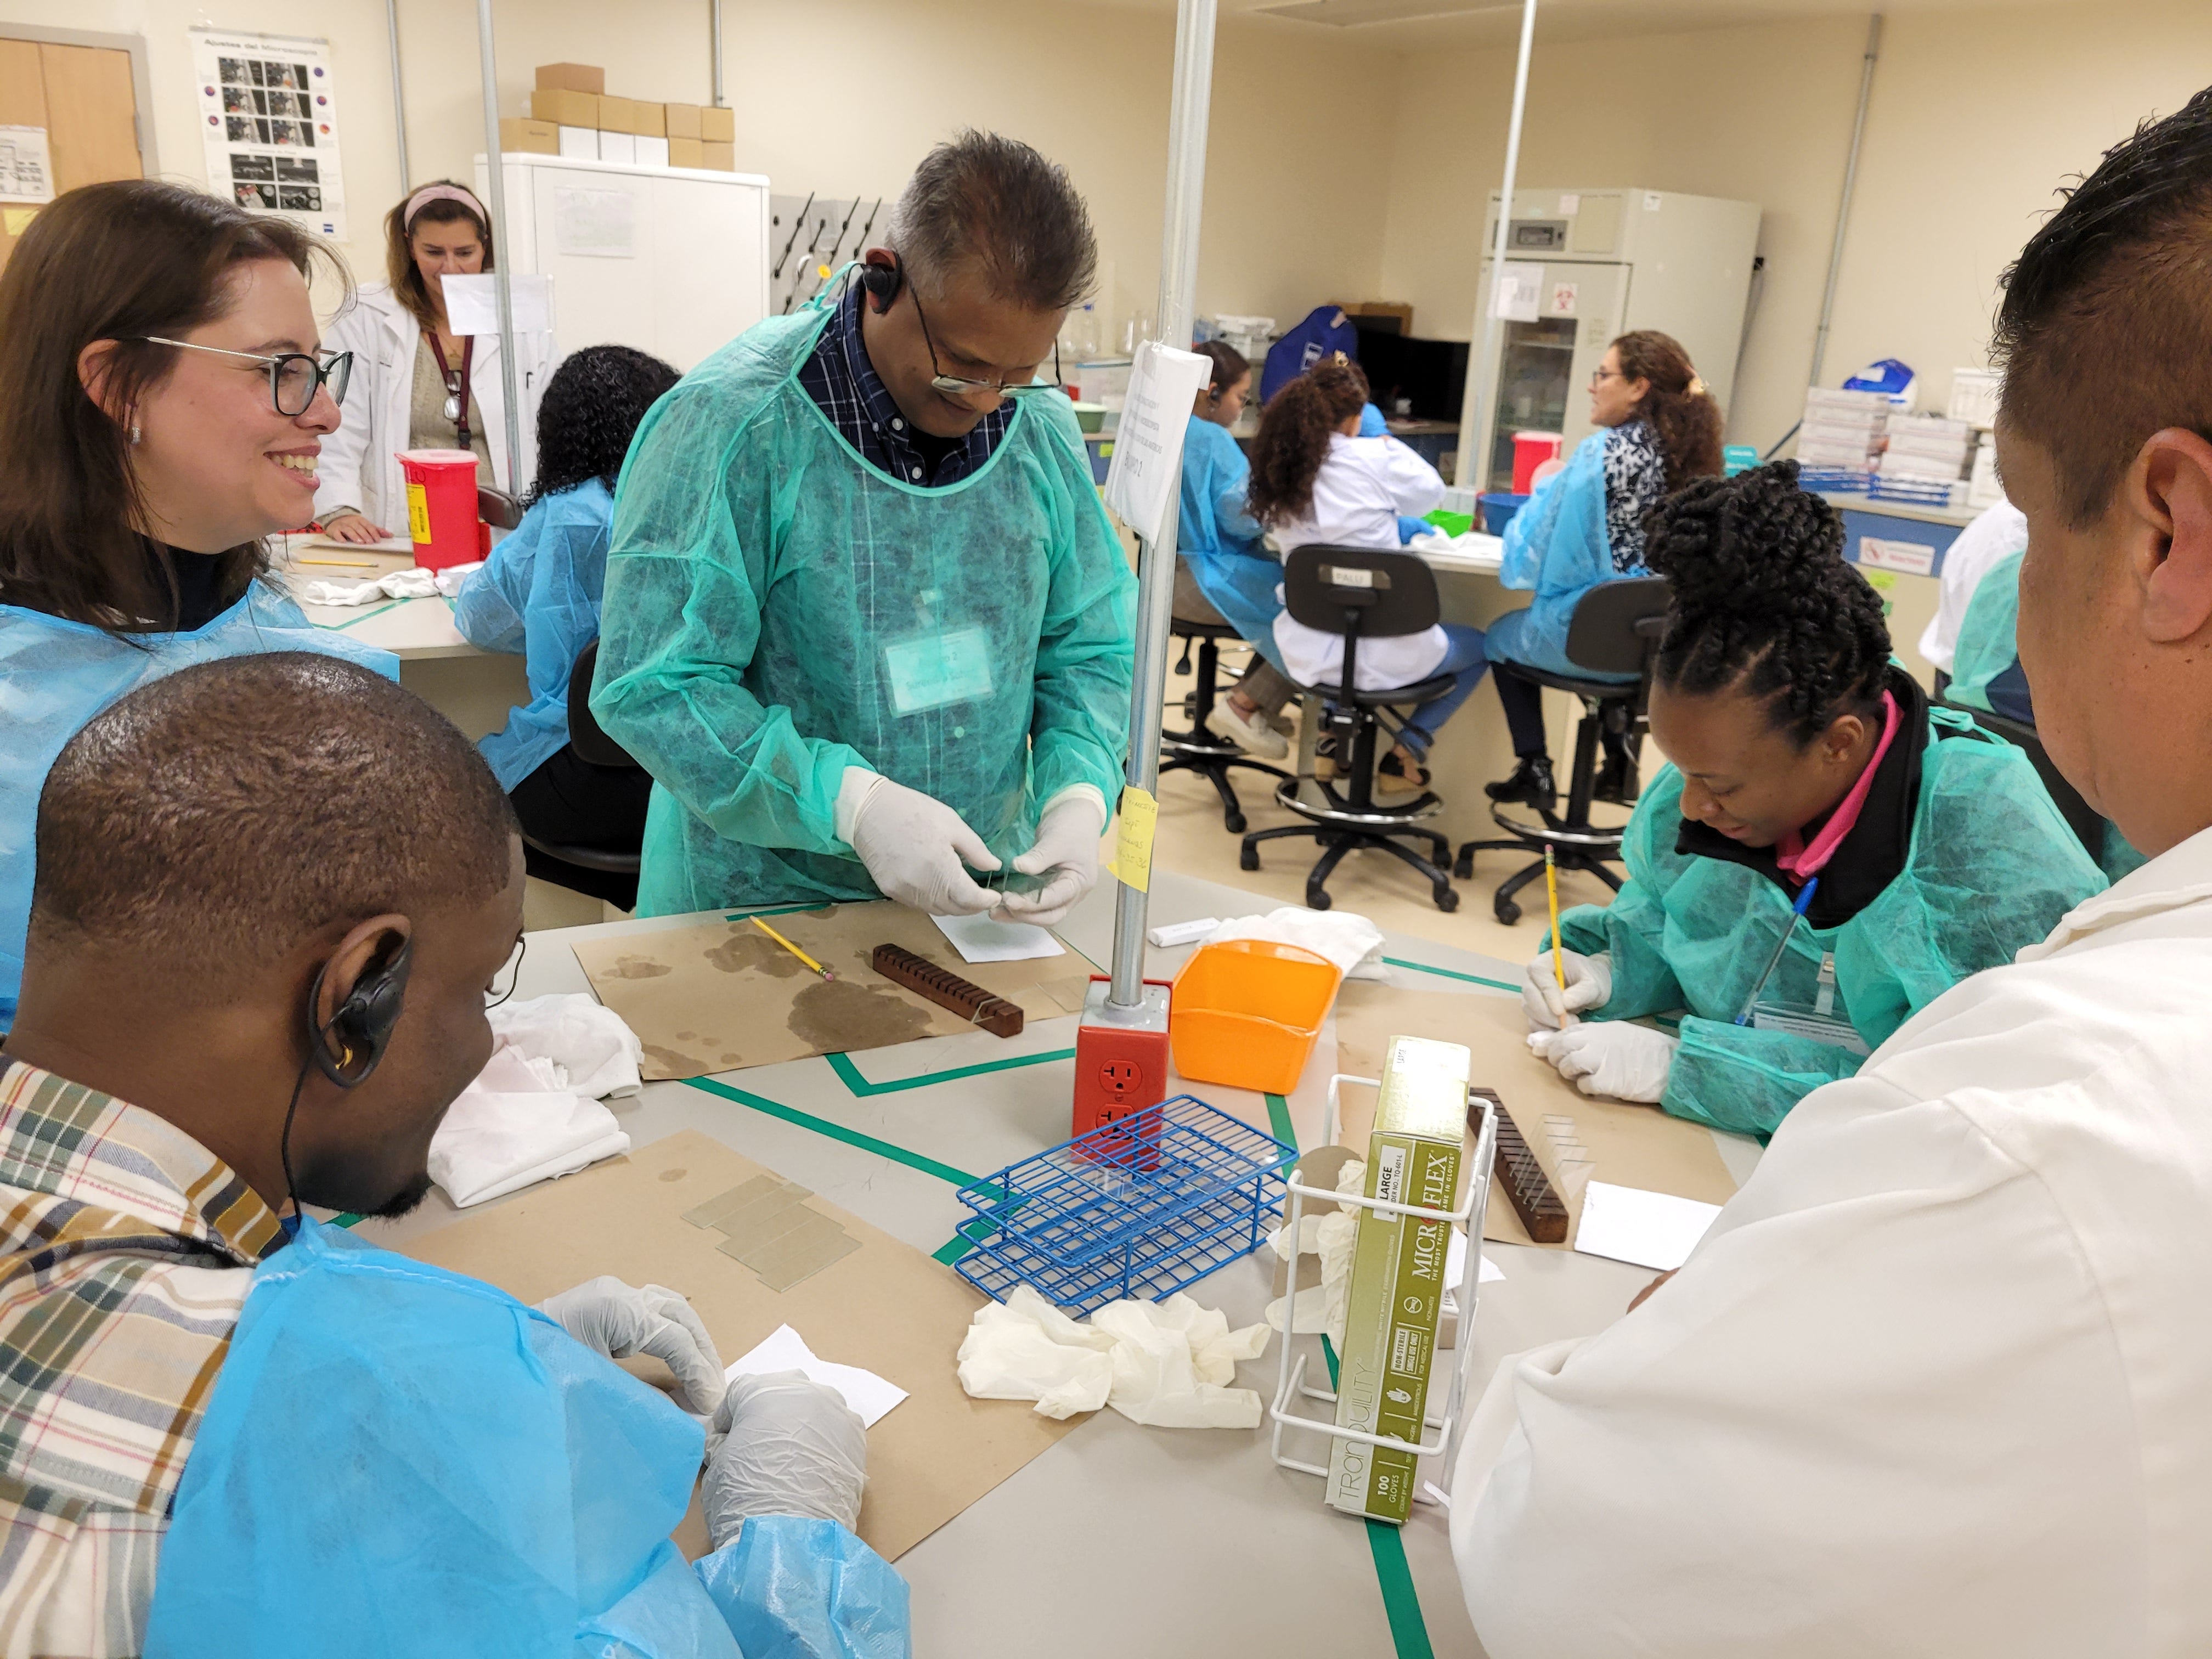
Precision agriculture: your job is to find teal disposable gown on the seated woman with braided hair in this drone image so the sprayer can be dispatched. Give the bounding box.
[1560,708,2106,1135]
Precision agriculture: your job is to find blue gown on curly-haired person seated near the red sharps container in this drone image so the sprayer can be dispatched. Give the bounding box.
[454,478,615,789]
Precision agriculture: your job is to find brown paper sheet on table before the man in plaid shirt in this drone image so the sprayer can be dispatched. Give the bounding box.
[403,1130,1075,1562]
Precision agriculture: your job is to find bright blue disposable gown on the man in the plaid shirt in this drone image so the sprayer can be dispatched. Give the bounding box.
[146,1221,909,1659]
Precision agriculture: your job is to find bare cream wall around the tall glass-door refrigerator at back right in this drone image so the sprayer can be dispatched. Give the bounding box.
[1383,0,2212,447]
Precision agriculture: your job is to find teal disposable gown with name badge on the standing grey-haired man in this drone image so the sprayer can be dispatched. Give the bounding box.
[591,290,1137,916]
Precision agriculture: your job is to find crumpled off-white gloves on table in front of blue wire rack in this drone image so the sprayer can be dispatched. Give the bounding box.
[960,1285,1267,1429]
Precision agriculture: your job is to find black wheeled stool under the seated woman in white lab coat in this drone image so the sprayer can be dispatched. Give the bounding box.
[1239,544,1460,911]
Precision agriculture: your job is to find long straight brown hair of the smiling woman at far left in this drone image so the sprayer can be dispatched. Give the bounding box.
[0,179,345,635]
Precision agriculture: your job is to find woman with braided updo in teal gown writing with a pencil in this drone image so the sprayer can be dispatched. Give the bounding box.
[1522,460,2106,1137]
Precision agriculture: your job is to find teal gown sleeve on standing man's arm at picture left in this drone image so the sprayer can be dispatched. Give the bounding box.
[591,383,865,854]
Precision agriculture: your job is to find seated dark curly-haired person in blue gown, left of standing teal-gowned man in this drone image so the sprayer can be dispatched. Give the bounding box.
[454,345,677,909]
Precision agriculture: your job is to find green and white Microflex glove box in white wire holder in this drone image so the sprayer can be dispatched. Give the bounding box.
[1329,1037,1471,1522]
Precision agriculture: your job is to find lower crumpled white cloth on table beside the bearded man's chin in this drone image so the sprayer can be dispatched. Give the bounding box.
[429,1042,630,1210]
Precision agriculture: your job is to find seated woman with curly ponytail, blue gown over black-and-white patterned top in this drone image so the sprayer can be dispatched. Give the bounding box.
[1482,328,1721,810]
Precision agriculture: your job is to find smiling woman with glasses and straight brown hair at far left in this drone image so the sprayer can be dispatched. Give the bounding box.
[0,179,398,1029]
